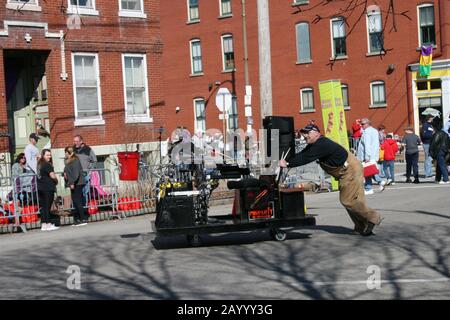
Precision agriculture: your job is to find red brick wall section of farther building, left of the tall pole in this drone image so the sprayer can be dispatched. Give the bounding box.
[161,0,260,136]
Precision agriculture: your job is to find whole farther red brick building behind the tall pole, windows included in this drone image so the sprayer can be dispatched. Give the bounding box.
[161,0,450,140]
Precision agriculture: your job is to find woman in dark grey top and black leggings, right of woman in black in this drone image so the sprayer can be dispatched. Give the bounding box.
[64,147,87,227]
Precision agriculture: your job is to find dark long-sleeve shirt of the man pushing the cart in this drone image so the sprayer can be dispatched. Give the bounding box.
[289,136,348,167]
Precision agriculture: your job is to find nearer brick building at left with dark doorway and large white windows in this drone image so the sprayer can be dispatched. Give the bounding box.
[0,0,165,170]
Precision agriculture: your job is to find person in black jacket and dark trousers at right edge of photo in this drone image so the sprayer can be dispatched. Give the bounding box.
[430,129,450,184]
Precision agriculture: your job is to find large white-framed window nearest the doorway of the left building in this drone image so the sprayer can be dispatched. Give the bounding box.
[72,53,102,122]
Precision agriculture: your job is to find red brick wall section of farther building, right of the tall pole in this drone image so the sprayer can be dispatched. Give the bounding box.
[270,0,441,134]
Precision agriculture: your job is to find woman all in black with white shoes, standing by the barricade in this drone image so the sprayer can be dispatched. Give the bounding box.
[37,149,59,231]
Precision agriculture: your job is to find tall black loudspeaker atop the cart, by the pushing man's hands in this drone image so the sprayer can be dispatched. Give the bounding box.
[263,116,295,161]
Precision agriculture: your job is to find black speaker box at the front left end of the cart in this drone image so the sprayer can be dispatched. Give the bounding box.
[155,196,195,228]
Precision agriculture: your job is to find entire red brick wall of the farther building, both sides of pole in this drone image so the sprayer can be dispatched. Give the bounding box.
[161,0,442,134]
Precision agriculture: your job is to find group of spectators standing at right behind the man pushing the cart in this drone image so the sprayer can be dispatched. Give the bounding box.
[351,115,450,195]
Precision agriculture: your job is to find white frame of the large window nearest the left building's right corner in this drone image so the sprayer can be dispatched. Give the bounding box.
[122,53,153,123]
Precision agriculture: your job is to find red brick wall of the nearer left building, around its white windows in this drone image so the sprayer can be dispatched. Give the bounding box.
[0,0,166,147]
